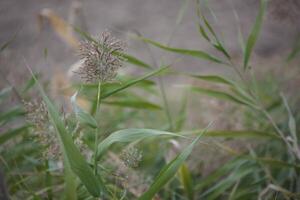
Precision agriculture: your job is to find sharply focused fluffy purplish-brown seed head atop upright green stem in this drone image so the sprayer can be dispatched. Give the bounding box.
[75,31,125,82]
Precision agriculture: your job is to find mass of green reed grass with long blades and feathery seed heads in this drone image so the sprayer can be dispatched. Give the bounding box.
[0,0,300,200]
